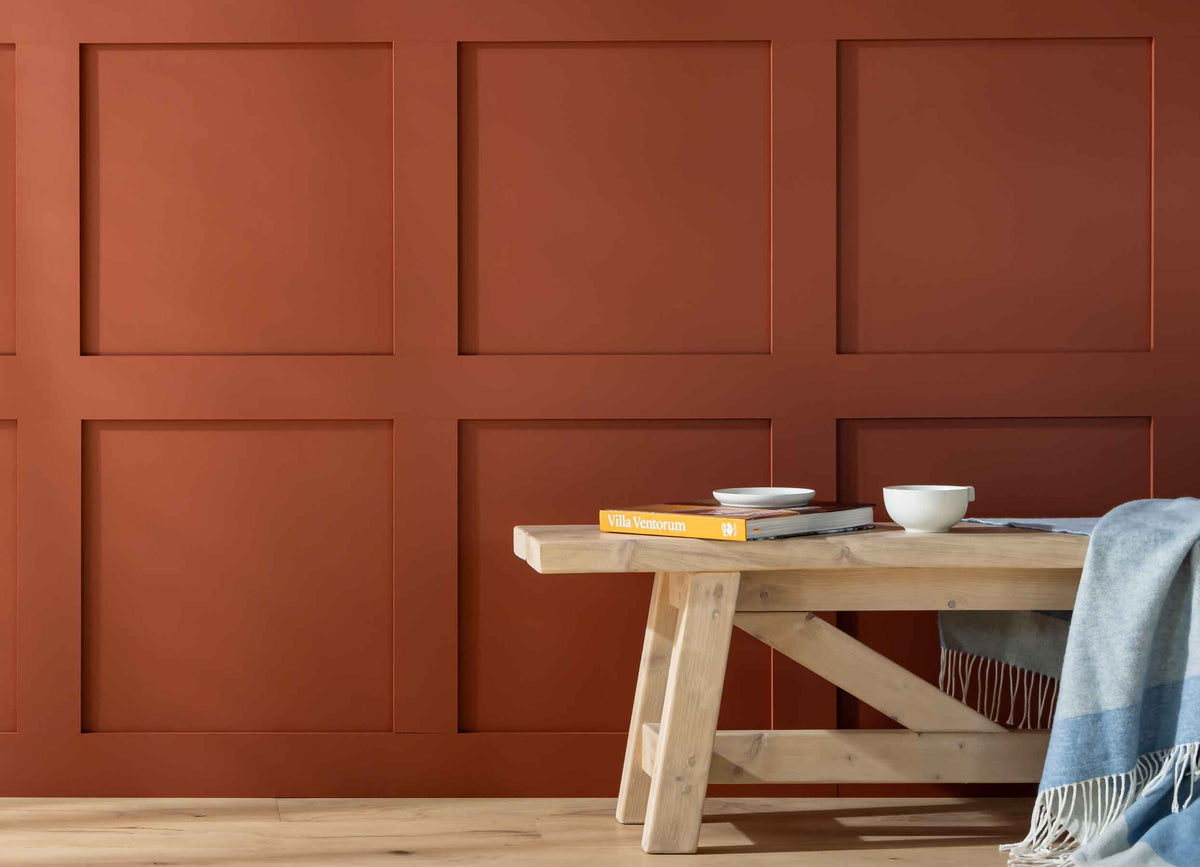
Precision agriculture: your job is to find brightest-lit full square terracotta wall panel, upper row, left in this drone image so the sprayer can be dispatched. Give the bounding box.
[80,44,392,354]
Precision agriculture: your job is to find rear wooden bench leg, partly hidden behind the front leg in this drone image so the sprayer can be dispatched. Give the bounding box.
[617,572,676,825]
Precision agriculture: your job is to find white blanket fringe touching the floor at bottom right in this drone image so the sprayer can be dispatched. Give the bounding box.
[1000,742,1200,867]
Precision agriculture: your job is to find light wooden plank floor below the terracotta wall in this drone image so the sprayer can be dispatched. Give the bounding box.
[0,799,1030,867]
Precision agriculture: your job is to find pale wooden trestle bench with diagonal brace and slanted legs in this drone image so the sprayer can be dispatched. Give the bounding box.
[514,524,1087,853]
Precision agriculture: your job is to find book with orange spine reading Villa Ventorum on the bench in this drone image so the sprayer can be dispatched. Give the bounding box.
[600,500,875,542]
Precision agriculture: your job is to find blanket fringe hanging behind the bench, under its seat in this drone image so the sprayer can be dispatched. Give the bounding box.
[937,647,1058,729]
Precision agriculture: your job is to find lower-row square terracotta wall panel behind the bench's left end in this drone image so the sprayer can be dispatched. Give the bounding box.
[458,420,770,731]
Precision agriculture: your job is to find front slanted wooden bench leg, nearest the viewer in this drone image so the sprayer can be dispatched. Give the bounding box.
[642,572,739,853]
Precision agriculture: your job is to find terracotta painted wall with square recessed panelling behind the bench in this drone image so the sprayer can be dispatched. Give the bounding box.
[0,0,1200,795]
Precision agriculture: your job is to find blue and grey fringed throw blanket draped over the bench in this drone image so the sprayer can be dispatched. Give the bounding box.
[942,498,1200,867]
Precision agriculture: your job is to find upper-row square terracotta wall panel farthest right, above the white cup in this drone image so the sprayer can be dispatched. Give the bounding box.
[838,38,1153,353]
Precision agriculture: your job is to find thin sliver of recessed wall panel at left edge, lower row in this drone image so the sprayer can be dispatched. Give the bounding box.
[0,420,17,731]
